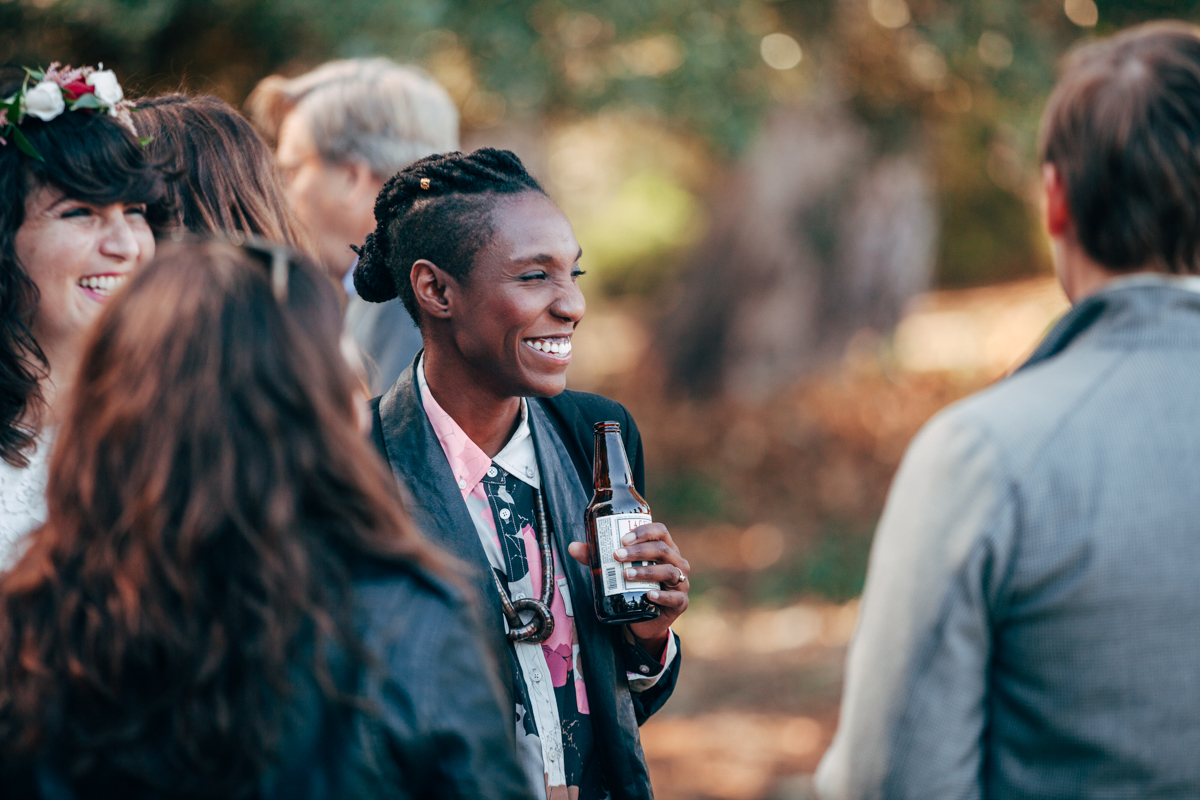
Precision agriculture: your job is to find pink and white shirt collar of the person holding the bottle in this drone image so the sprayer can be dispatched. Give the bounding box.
[416,355,541,498]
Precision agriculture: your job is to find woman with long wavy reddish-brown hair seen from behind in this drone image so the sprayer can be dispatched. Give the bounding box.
[0,237,528,800]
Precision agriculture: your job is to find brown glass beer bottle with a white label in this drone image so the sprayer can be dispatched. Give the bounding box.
[583,422,661,625]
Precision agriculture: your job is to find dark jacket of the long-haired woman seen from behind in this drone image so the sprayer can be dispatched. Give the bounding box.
[10,564,533,800]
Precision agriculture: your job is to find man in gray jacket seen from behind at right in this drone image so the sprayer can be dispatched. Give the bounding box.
[816,24,1200,800]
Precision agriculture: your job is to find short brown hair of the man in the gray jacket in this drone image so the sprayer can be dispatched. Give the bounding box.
[1042,23,1200,272]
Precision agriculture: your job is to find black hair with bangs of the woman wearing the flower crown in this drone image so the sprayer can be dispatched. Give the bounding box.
[0,68,163,467]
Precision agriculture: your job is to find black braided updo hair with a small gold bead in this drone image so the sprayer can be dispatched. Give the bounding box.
[354,148,545,324]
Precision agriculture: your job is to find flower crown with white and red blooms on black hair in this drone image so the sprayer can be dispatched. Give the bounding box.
[0,61,140,161]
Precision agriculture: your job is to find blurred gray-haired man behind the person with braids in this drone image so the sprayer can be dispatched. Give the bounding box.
[247,59,458,395]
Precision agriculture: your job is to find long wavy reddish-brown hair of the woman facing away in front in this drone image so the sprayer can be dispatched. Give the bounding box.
[0,242,445,799]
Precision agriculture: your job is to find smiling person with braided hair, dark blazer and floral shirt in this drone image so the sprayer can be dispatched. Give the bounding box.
[354,149,689,800]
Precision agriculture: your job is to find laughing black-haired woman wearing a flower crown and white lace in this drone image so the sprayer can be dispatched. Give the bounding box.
[0,64,164,570]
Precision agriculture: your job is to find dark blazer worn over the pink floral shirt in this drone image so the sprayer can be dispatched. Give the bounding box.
[372,367,680,800]
